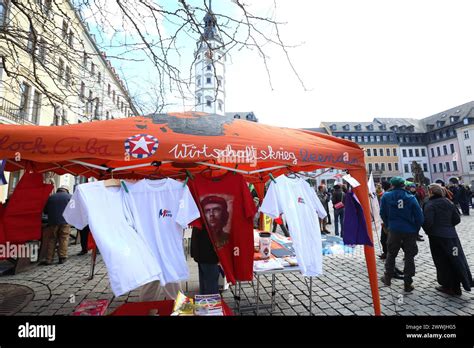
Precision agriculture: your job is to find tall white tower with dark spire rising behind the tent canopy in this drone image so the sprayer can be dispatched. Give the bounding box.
[194,0,226,115]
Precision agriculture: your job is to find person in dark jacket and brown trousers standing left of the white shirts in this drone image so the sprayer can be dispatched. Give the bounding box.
[42,185,71,265]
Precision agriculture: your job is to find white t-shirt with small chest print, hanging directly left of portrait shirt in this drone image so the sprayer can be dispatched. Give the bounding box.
[125,178,200,286]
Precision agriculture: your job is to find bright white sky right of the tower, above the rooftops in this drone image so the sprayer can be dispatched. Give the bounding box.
[224,0,474,127]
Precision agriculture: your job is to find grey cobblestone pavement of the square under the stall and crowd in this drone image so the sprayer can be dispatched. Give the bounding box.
[0,215,474,316]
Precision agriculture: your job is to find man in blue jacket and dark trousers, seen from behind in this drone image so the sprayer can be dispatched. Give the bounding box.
[380,177,423,292]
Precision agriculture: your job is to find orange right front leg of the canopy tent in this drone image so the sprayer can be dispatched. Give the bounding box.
[351,168,382,315]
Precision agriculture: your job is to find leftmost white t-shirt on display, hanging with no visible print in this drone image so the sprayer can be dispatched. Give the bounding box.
[63,181,161,296]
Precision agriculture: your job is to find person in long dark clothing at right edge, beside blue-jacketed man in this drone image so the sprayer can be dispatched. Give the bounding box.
[423,184,474,296]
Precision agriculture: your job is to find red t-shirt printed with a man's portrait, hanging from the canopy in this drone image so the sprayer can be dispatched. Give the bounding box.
[188,172,257,284]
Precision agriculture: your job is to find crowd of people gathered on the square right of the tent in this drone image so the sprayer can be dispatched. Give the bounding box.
[317,177,474,296]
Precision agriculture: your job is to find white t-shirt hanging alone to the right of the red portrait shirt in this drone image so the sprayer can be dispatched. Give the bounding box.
[260,175,326,276]
